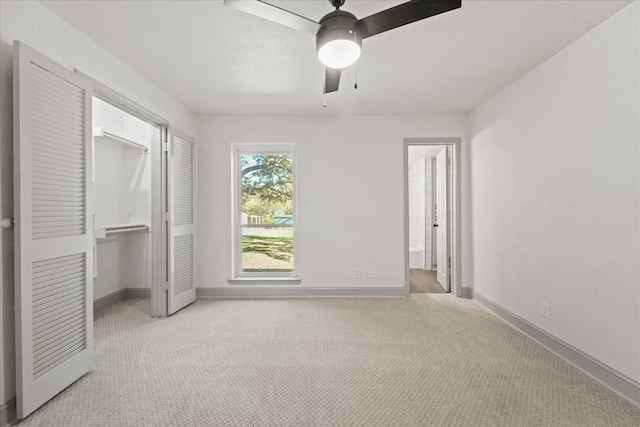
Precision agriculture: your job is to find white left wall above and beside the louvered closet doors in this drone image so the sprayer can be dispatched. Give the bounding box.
[0,0,196,408]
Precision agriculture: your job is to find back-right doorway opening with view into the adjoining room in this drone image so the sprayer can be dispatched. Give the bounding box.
[404,139,460,296]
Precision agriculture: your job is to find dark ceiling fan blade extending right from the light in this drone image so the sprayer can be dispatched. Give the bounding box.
[356,0,462,39]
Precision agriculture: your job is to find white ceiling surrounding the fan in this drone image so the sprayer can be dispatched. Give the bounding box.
[41,0,629,115]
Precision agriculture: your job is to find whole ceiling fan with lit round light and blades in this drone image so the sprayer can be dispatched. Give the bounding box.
[224,0,462,93]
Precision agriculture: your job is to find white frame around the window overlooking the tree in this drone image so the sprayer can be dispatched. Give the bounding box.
[231,143,299,279]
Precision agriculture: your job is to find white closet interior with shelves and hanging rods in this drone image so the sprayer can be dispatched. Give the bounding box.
[92,97,157,307]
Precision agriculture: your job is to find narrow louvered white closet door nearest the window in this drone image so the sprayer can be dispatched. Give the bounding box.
[168,131,196,314]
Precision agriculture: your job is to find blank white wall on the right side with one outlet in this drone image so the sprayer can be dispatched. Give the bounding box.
[471,2,640,381]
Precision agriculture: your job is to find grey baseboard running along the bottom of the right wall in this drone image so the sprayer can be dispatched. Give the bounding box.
[467,288,640,407]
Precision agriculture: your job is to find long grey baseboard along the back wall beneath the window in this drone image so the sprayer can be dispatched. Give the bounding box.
[196,287,406,298]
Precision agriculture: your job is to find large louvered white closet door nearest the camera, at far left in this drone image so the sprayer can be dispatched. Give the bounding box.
[13,42,93,418]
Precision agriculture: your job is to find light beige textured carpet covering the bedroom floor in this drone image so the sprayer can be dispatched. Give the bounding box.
[16,294,640,427]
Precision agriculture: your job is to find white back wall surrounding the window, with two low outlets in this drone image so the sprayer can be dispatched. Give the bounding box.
[197,116,469,288]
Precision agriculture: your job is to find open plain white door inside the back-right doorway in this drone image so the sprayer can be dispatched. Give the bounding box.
[436,147,449,292]
